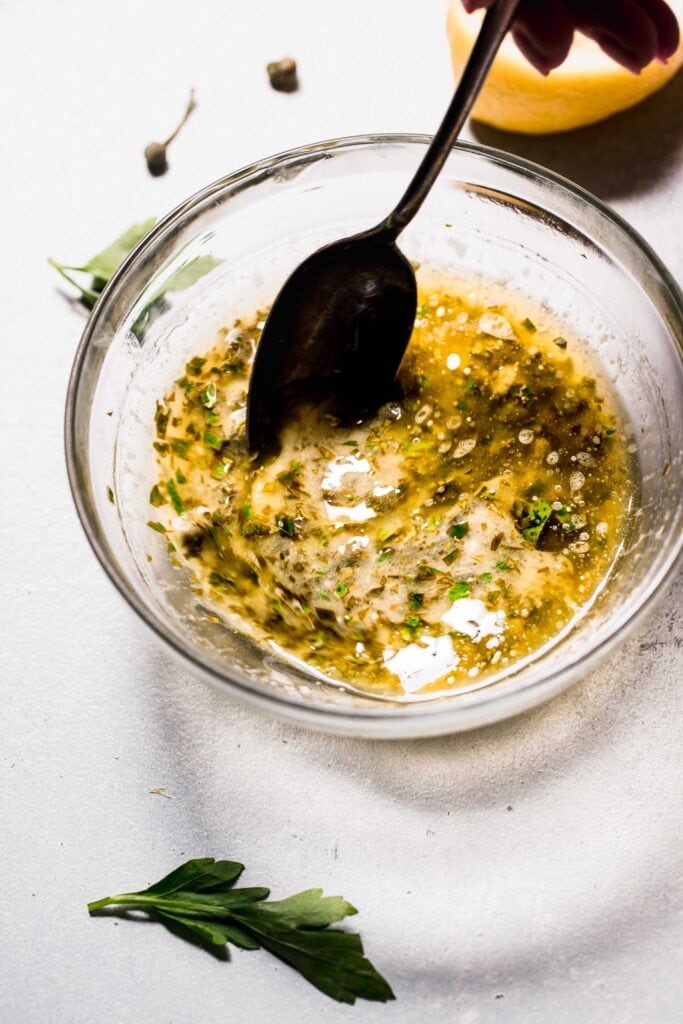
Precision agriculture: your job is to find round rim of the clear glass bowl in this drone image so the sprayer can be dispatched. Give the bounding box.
[65,132,683,737]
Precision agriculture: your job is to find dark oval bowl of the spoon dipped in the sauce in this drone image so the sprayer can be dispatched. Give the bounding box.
[247,231,418,456]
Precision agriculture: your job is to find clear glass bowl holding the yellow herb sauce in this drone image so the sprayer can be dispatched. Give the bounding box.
[66,135,683,737]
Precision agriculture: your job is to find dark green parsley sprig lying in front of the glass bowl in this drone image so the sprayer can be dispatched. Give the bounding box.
[88,857,394,1004]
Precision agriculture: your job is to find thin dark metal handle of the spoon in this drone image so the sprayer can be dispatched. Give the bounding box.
[373,0,521,241]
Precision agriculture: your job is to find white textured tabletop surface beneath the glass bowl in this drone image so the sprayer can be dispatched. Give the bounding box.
[0,0,683,1024]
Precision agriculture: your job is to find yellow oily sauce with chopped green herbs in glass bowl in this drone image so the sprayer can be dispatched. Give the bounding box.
[150,283,634,695]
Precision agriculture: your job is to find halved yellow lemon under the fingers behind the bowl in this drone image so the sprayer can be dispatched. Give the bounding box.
[447,0,683,135]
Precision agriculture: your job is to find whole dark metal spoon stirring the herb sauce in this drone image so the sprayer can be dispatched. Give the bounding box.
[247,0,520,457]
